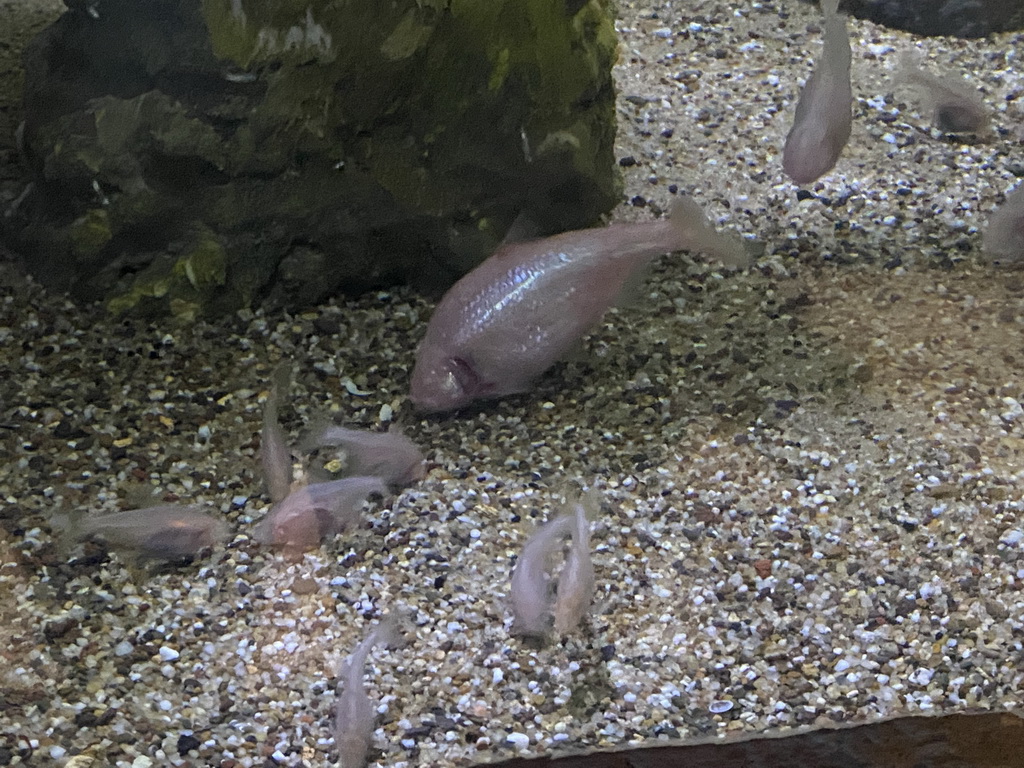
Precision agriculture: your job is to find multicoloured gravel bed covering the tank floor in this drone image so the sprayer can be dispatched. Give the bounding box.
[0,0,1024,768]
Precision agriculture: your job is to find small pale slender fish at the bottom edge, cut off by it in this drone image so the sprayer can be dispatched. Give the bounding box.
[334,613,401,768]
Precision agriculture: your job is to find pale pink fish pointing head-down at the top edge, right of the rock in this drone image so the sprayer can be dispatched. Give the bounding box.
[782,0,853,184]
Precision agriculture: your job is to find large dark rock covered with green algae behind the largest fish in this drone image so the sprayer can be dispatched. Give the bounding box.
[22,0,620,316]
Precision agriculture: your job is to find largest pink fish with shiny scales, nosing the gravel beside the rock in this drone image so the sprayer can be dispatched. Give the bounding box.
[410,198,746,411]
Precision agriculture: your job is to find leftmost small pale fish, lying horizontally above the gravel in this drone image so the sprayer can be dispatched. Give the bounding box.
[69,504,227,560]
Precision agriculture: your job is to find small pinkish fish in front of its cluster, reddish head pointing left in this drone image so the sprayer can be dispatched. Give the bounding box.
[254,477,387,552]
